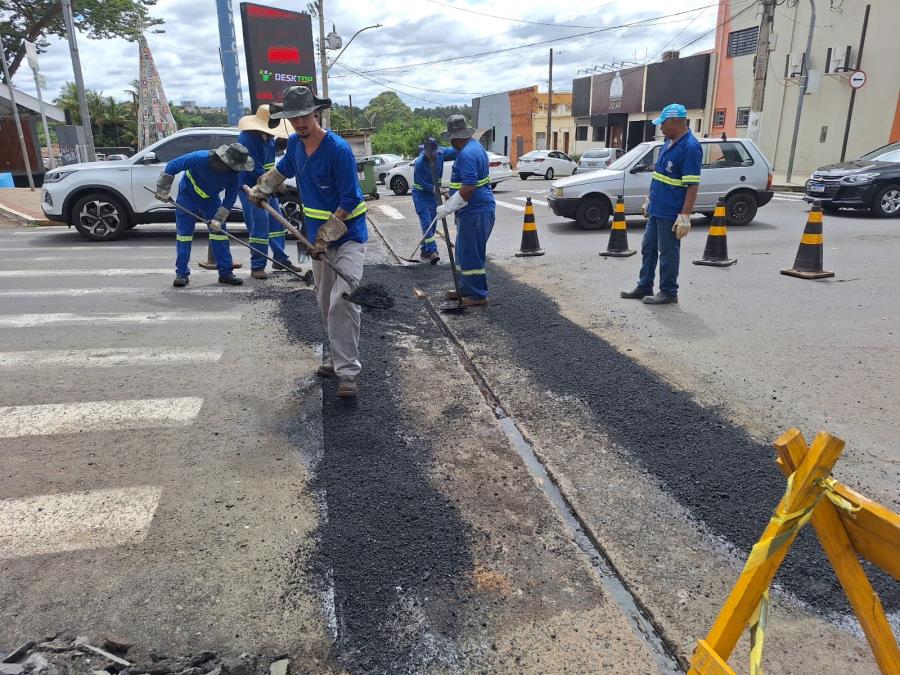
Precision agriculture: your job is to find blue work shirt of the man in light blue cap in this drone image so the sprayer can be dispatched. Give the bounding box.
[649,130,703,220]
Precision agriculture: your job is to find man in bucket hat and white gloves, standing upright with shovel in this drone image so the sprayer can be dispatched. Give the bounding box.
[437,115,497,307]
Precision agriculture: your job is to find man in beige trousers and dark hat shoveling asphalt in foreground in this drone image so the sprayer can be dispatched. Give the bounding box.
[250,86,369,398]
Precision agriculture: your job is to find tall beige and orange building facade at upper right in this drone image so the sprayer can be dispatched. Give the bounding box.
[705,0,900,178]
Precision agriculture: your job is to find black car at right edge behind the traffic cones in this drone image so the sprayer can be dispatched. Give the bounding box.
[806,143,900,218]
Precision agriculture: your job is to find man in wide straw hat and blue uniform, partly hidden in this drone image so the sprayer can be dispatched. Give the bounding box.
[238,105,302,279]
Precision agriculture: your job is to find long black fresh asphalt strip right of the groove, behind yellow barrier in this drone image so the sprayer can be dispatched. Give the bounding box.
[395,265,900,614]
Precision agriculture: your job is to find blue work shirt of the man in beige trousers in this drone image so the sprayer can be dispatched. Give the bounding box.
[275,131,369,246]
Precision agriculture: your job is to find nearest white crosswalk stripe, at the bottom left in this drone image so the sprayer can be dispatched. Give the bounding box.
[0,486,162,560]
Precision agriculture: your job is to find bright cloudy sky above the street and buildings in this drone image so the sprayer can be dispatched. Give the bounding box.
[8,0,740,107]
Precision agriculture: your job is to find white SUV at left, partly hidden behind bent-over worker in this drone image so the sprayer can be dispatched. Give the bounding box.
[41,127,248,241]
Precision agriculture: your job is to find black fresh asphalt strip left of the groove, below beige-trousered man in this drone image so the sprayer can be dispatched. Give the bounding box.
[272,274,473,673]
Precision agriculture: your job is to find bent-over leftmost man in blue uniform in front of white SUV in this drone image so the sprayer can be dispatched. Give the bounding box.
[156,143,253,287]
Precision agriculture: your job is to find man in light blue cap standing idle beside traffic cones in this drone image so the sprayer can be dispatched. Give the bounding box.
[621,103,703,305]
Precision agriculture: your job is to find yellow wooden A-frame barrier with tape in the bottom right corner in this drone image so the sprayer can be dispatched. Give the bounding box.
[689,429,900,675]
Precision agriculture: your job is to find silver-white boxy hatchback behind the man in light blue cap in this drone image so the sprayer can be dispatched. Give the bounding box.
[547,138,772,230]
